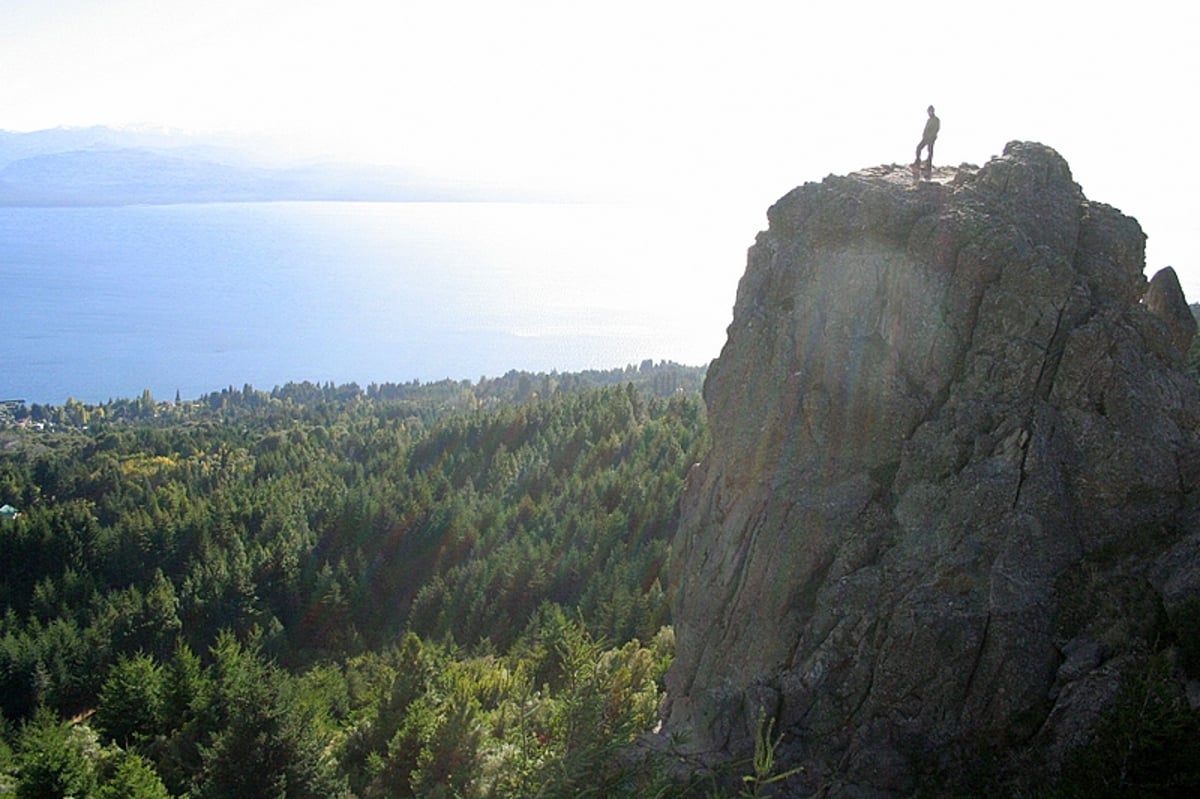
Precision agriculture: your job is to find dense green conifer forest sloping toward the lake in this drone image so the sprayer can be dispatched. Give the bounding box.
[0,362,708,798]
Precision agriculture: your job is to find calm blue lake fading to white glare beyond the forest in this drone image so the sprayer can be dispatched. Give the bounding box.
[0,203,734,404]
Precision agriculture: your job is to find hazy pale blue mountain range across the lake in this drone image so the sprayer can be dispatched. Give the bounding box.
[0,127,528,206]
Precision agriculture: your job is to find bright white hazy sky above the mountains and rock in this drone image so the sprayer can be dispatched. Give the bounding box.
[0,0,1200,295]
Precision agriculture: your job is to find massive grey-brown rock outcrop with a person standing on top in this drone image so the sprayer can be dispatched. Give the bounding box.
[665,143,1200,795]
